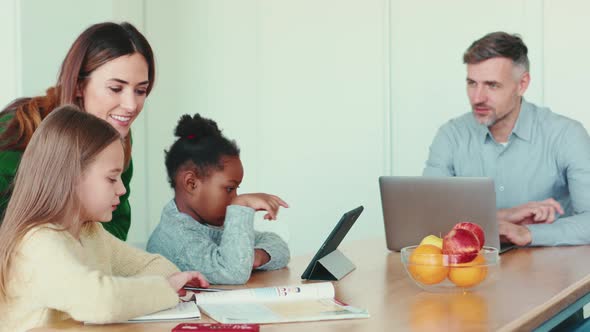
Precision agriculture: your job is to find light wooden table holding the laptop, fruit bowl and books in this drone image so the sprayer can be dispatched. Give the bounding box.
[35,239,590,332]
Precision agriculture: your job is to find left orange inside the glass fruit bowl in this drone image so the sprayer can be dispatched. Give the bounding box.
[408,244,449,285]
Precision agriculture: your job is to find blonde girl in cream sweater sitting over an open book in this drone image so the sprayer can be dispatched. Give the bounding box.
[0,105,209,332]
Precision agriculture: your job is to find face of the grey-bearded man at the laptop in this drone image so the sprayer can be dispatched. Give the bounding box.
[467,58,530,127]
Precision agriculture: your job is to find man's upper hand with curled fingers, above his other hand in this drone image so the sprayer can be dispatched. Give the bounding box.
[496,198,564,225]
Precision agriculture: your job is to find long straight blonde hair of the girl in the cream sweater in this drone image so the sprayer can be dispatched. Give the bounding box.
[0,105,123,302]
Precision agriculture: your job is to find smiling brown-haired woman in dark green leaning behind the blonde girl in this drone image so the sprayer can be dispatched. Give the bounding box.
[0,22,155,240]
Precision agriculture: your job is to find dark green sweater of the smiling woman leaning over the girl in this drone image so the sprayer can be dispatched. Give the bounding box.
[0,113,133,241]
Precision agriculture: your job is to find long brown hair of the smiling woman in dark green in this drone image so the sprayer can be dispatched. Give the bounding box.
[0,22,156,164]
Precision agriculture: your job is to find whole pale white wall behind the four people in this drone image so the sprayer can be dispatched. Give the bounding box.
[0,0,590,254]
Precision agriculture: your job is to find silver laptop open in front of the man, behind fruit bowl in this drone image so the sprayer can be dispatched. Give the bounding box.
[379,176,507,251]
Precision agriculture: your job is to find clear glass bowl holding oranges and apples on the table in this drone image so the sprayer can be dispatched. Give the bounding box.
[401,246,500,292]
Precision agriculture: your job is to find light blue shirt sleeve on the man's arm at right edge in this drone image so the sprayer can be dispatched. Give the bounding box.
[527,122,590,246]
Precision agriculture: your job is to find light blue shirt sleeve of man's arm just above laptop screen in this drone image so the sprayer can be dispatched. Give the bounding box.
[422,123,456,176]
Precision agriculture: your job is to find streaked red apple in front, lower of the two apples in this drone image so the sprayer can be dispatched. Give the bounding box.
[442,229,480,264]
